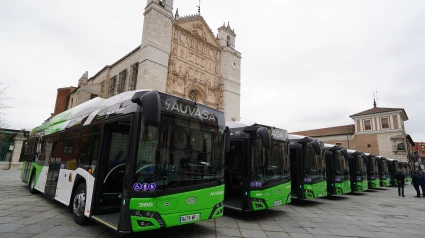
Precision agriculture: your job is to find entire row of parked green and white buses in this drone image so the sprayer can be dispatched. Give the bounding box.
[21,90,410,234]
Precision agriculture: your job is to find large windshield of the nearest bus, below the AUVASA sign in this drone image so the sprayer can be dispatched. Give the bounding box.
[135,115,224,191]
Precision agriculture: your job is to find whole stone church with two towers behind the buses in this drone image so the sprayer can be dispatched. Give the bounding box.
[54,0,241,121]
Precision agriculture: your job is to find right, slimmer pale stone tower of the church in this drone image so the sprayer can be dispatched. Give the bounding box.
[218,23,241,121]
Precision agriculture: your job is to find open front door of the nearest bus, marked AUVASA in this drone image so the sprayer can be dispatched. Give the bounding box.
[93,117,131,229]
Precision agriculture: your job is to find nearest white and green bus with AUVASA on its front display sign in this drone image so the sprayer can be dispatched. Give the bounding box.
[21,90,229,234]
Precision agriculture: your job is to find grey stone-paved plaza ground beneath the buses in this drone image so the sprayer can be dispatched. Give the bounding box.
[0,170,425,238]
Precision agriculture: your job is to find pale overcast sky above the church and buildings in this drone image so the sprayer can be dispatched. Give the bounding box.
[0,0,425,141]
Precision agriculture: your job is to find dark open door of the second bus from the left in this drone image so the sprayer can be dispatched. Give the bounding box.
[224,140,243,208]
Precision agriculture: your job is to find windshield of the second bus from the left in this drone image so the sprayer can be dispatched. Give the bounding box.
[251,138,290,186]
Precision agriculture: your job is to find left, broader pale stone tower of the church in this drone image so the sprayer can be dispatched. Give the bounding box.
[136,0,173,92]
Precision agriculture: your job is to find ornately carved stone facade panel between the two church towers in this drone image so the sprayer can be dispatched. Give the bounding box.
[166,21,222,109]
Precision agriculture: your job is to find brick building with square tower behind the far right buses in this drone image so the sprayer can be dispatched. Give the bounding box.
[291,100,415,162]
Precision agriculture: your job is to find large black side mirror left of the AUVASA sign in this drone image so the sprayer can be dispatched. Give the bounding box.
[131,91,161,126]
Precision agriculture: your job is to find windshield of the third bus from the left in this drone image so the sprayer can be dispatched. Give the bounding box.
[304,143,325,183]
